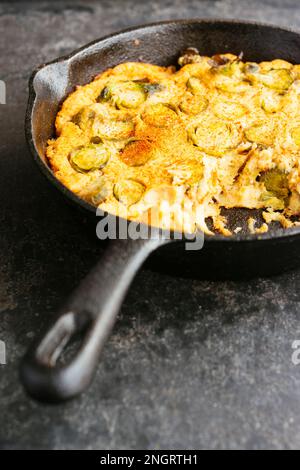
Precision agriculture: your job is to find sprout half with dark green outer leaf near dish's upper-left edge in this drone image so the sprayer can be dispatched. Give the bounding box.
[99,81,146,108]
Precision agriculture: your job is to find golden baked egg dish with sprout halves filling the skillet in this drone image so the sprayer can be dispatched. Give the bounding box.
[46,48,300,236]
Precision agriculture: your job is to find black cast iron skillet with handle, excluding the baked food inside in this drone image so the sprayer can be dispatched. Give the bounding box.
[21,20,300,402]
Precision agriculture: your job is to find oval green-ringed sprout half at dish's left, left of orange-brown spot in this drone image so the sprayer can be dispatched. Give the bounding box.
[69,144,110,173]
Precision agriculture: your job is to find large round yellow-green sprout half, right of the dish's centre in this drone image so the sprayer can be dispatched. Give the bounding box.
[191,119,239,156]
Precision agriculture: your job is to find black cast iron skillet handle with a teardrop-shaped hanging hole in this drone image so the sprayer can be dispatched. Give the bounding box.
[20,237,168,403]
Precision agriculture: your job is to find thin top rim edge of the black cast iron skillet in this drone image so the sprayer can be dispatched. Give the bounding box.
[25,18,300,242]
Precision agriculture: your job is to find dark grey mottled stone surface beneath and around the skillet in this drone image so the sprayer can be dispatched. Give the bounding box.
[0,0,300,449]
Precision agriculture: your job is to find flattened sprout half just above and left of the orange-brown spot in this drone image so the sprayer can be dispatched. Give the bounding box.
[93,118,134,140]
